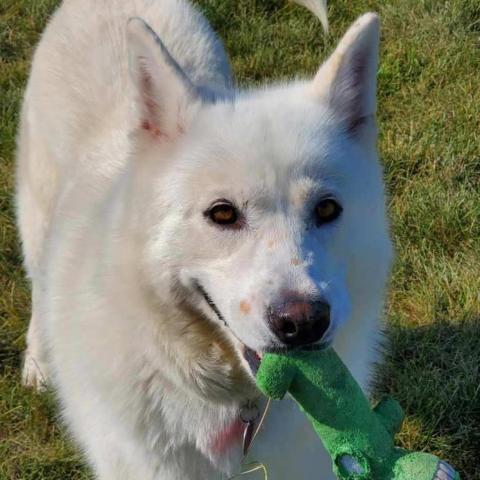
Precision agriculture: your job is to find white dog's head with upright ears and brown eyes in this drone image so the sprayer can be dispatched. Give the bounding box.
[125,14,391,394]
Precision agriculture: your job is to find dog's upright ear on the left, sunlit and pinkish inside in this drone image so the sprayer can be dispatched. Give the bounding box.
[127,18,200,141]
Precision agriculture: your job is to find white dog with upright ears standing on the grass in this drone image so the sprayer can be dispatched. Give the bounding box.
[17,0,391,480]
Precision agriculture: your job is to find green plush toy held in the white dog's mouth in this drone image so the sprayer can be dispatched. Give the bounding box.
[257,348,460,480]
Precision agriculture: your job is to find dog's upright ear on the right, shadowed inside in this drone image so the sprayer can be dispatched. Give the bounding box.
[311,13,380,133]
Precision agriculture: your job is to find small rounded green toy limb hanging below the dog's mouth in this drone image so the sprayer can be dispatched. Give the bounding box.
[257,353,296,400]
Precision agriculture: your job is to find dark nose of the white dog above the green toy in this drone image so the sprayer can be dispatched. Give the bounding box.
[267,300,330,346]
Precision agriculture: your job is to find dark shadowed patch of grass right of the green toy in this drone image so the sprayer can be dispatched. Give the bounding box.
[375,319,480,480]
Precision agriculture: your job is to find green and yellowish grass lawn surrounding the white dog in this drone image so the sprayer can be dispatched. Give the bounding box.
[0,0,480,480]
